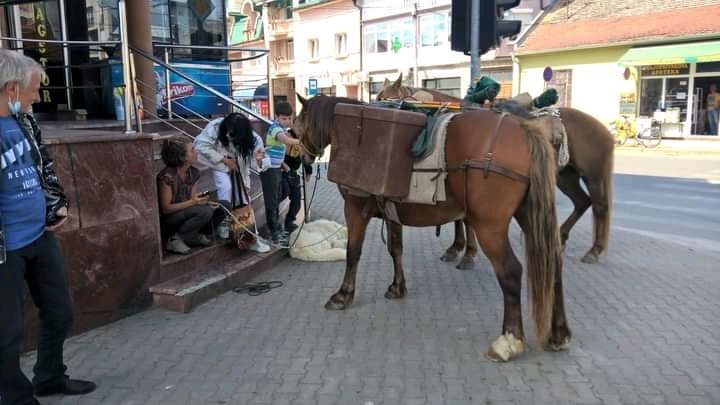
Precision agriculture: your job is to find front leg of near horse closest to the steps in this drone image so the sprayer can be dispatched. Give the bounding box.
[325,196,372,309]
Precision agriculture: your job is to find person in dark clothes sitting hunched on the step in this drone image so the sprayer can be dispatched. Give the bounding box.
[157,139,226,254]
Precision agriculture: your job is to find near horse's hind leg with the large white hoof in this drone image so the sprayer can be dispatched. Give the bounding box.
[475,224,525,361]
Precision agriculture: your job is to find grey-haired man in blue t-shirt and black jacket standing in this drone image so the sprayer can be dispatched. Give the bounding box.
[0,49,95,405]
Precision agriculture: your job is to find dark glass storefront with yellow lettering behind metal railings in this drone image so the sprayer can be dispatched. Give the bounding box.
[0,0,229,118]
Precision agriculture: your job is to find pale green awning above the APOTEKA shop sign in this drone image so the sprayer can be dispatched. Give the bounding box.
[618,41,720,66]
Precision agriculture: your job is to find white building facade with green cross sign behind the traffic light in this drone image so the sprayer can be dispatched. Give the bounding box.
[359,0,549,100]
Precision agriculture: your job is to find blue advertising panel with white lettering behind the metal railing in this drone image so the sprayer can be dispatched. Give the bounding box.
[112,62,230,117]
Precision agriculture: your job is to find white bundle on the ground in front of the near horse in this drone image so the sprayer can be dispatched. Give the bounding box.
[289,219,347,262]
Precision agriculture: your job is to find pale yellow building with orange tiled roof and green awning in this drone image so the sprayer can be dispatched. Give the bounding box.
[516,0,720,137]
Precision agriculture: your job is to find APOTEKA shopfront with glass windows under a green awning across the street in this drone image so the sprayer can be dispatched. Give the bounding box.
[620,41,720,137]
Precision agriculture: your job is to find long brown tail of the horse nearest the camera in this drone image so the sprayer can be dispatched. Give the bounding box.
[522,120,562,347]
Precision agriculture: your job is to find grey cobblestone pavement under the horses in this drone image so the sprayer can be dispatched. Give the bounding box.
[23,163,720,404]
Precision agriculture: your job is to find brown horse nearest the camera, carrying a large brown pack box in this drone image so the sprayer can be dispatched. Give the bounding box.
[293,96,570,361]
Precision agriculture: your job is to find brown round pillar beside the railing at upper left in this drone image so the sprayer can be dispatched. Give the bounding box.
[126,1,157,118]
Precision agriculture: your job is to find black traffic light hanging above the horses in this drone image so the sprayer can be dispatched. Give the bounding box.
[450,0,522,55]
